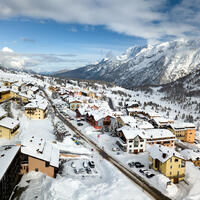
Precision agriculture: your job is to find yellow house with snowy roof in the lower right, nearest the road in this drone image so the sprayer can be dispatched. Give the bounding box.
[148,144,185,183]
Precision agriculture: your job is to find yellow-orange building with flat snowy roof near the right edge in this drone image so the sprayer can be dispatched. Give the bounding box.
[168,123,196,143]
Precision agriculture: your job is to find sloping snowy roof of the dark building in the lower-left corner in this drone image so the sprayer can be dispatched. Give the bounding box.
[0,145,20,180]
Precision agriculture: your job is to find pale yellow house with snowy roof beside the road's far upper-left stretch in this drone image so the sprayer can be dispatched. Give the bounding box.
[24,101,48,119]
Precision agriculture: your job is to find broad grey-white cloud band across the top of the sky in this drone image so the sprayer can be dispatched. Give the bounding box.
[0,0,200,41]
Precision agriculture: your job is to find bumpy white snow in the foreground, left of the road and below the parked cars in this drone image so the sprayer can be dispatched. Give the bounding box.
[17,152,151,200]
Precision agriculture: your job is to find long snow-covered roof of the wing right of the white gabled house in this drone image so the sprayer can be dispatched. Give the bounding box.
[145,129,175,139]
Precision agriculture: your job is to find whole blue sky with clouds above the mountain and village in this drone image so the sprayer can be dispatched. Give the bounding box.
[0,0,200,71]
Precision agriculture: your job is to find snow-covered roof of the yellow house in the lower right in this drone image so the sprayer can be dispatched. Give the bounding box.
[147,144,184,163]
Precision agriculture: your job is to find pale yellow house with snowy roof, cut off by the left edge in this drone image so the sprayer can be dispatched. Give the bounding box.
[0,117,20,139]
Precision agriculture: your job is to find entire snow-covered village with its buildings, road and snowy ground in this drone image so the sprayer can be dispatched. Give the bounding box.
[0,66,200,200]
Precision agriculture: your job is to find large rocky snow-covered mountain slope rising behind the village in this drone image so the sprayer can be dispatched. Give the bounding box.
[57,39,200,87]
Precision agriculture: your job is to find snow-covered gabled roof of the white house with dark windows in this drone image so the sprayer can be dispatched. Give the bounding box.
[117,126,146,140]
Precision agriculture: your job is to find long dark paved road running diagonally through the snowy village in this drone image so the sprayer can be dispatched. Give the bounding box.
[43,88,170,200]
